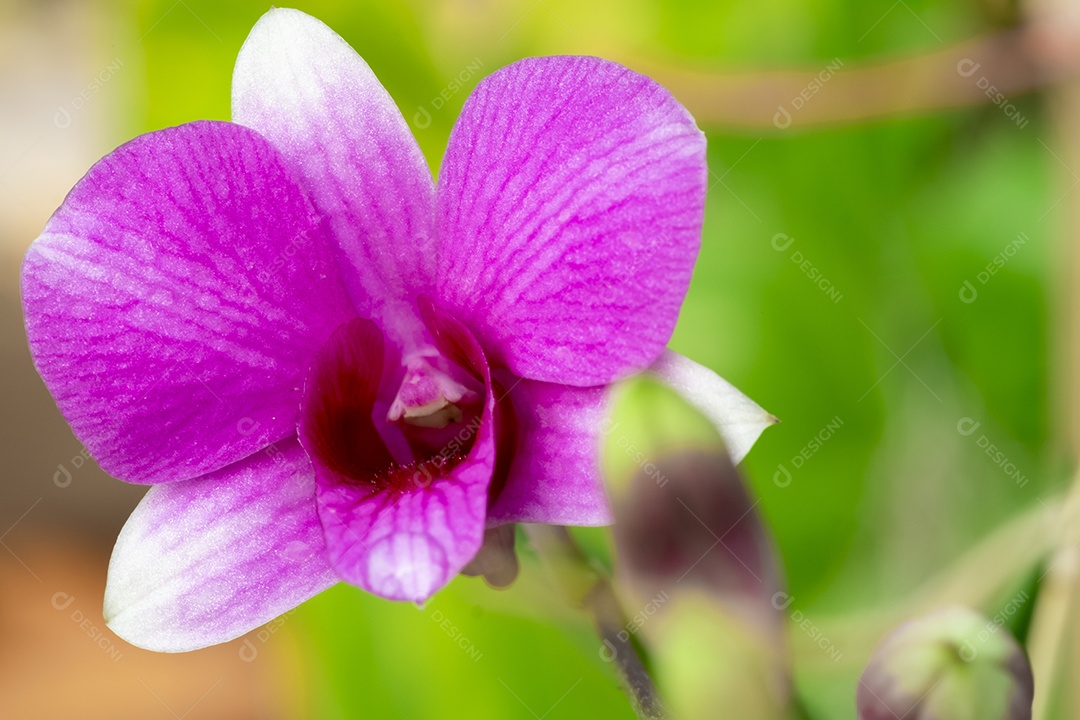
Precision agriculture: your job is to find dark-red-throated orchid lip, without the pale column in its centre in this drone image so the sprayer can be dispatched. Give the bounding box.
[300,304,495,602]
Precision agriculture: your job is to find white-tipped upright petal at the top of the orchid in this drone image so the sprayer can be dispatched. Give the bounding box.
[232,9,435,349]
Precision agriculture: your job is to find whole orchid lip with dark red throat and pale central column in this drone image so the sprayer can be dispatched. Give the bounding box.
[299,297,513,601]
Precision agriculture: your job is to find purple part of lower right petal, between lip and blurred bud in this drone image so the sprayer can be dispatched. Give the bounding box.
[487,377,611,526]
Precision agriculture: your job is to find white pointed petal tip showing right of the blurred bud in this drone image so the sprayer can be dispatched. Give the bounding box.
[648,350,780,464]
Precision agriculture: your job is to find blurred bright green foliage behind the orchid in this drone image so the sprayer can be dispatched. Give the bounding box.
[116,0,1063,718]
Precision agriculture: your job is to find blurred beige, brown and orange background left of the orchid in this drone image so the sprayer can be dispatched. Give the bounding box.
[0,0,307,720]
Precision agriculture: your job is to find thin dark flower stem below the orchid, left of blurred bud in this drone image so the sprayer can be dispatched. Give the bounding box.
[524,525,666,720]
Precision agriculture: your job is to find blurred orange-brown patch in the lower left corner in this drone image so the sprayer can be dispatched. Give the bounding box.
[0,533,306,720]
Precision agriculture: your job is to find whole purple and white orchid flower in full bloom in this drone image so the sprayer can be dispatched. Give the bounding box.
[23,10,772,651]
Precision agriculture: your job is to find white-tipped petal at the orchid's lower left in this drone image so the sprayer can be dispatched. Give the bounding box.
[105,439,337,652]
